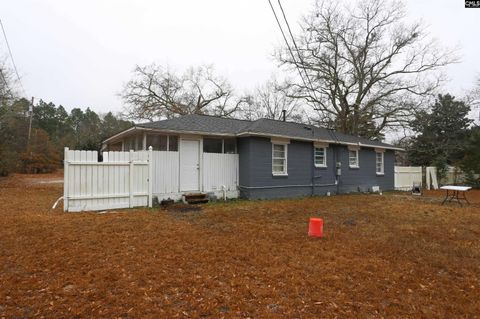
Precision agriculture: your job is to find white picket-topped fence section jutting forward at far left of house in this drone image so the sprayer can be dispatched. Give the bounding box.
[63,147,152,212]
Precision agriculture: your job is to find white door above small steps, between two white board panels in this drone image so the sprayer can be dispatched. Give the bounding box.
[180,140,200,192]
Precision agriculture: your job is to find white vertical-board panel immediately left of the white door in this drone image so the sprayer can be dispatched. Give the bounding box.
[152,151,180,194]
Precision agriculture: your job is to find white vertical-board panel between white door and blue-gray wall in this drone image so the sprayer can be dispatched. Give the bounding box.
[203,153,238,191]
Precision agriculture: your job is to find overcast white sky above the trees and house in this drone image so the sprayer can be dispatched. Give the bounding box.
[0,0,480,117]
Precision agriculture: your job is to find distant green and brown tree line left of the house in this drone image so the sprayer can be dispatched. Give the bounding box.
[0,95,132,176]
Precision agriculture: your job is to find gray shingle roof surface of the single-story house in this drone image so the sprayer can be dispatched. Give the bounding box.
[130,114,397,149]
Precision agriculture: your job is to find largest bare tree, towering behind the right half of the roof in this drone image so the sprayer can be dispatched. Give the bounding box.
[278,0,456,138]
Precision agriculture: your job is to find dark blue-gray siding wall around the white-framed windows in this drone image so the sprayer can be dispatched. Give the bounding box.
[237,137,394,199]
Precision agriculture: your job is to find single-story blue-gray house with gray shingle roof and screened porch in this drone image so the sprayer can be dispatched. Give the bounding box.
[103,115,402,199]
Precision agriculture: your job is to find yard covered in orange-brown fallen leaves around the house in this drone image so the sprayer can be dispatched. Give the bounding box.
[0,174,480,318]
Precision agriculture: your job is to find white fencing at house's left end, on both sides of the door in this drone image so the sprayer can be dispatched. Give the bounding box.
[64,148,239,212]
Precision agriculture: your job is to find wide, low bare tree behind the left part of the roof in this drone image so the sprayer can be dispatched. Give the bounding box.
[121,64,238,121]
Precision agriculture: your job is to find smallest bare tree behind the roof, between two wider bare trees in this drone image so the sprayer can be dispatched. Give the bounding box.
[239,76,306,122]
